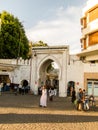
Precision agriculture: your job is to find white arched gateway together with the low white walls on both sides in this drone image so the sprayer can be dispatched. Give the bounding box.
[0,46,83,97]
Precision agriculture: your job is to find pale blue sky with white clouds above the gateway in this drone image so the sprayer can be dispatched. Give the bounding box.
[0,0,87,54]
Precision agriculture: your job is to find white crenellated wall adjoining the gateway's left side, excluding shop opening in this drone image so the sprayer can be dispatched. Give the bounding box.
[0,59,30,84]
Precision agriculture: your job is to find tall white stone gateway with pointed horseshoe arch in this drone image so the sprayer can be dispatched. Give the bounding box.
[30,46,69,97]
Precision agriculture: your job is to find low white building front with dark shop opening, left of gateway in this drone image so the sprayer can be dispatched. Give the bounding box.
[0,58,31,88]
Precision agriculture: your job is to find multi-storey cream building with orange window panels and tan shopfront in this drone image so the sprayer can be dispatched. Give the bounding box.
[78,0,98,96]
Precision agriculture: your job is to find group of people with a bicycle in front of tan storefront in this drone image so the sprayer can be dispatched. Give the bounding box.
[71,88,95,110]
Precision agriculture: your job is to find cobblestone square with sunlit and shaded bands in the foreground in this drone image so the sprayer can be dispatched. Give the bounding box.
[0,94,98,130]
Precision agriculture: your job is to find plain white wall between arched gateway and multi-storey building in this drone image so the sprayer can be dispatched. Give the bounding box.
[67,55,84,91]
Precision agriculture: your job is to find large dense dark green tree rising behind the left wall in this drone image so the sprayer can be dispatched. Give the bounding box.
[0,11,29,59]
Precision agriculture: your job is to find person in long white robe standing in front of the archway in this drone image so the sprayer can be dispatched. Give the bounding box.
[40,86,47,107]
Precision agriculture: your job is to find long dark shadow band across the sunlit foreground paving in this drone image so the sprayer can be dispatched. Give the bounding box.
[0,113,98,124]
